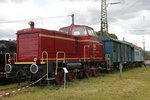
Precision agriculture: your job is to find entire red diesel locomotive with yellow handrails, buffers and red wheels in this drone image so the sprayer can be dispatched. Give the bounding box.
[5,22,106,83]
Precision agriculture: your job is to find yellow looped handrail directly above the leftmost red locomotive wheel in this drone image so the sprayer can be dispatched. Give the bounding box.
[55,51,66,75]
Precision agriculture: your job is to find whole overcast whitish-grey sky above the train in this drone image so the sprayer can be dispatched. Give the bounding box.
[0,0,150,51]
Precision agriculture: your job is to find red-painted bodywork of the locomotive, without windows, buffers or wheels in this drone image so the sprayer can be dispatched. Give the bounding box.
[17,25,103,62]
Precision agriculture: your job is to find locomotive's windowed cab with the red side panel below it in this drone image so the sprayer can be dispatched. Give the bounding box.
[59,24,103,61]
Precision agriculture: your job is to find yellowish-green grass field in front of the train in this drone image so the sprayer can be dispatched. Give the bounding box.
[0,67,150,100]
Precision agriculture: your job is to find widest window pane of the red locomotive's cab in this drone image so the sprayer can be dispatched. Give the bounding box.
[72,27,87,36]
